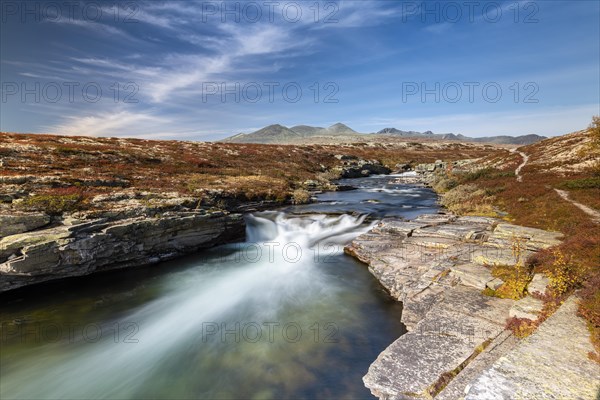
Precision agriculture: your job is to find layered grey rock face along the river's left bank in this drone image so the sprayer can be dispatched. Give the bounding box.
[0,212,244,292]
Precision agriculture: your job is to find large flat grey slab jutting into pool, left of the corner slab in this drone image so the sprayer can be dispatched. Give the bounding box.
[363,286,513,399]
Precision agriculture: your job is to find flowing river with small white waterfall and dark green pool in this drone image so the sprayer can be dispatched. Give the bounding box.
[0,176,435,399]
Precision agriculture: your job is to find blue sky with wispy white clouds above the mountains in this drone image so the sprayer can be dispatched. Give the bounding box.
[0,0,600,140]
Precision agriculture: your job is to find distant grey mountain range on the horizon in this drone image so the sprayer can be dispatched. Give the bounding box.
[221,123,546,145]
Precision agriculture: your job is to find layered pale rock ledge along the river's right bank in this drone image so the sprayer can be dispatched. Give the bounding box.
[345,214,561,399]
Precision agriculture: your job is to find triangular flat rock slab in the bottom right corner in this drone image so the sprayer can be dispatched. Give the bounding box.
[466,296,600,400]
